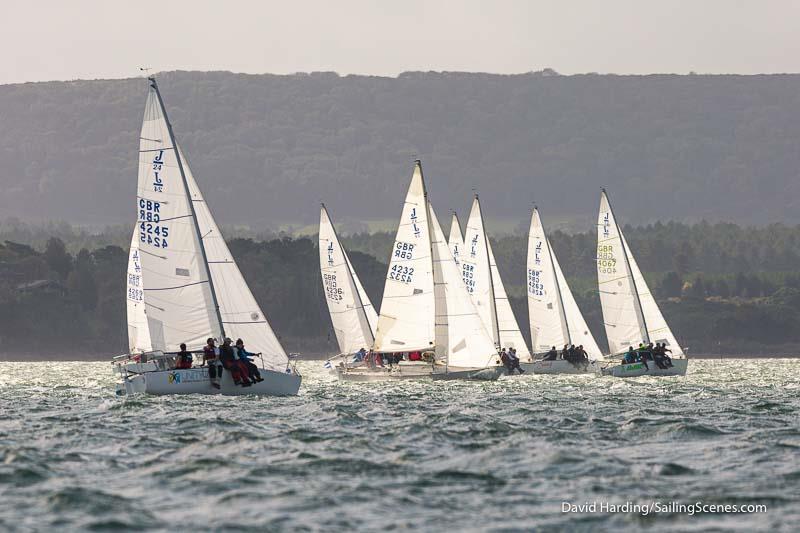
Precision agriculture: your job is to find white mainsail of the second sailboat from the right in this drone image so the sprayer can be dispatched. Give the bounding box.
[526,209,568,353]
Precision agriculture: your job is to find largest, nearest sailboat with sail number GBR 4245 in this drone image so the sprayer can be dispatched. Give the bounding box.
[113,77,301,395]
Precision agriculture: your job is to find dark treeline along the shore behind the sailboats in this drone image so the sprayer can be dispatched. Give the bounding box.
[0,218,800,355]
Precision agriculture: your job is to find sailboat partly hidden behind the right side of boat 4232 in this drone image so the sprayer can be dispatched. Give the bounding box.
[461,194,533,363]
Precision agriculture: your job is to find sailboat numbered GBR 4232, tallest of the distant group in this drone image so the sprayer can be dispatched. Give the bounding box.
[337,161,503,381]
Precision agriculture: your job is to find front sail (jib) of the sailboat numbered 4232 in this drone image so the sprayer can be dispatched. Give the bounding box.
[428,203,500,368]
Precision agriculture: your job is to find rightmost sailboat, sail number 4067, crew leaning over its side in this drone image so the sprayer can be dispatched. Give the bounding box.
[597,189,688,377]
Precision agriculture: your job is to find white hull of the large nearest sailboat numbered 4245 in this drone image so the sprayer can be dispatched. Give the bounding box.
[117,367,302,396]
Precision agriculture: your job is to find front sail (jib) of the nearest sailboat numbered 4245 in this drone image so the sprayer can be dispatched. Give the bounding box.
[178,147,289,371]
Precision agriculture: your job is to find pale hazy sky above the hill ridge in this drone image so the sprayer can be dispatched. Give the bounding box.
[0,0,800,83]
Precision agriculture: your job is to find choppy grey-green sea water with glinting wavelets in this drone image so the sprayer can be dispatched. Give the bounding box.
[0,360,800,531]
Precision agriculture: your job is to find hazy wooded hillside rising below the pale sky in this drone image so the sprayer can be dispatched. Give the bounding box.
[0,72,800,230]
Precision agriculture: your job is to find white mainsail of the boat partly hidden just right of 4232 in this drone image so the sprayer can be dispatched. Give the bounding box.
[461,194,500,346]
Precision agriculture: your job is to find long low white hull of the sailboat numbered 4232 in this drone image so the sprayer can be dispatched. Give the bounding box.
[336,363,505,382]
